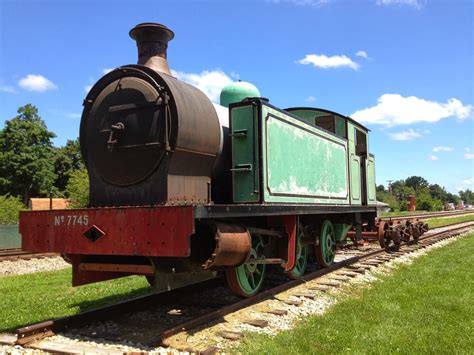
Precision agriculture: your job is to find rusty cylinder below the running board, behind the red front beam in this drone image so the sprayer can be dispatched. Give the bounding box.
[203,222,252,270]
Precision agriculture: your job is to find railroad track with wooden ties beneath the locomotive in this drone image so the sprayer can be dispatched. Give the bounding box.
[0,222,474,352]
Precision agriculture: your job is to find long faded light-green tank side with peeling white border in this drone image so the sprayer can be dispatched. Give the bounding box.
[261,105,349,204]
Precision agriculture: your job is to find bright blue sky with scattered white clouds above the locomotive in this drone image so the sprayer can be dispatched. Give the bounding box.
[0,0,474,192]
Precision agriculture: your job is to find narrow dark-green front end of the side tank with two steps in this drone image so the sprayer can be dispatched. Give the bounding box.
[230,105,260,203]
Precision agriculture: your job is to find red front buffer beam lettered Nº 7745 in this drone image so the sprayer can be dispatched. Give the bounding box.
[20,206,194,257]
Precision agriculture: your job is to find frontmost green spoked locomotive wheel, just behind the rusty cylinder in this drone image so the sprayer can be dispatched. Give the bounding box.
[225,236,265,297]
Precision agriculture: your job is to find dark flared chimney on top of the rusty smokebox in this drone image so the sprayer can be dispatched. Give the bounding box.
[129,22,174,75]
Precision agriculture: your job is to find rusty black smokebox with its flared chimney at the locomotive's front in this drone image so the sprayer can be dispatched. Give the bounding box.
[80,23,223,207]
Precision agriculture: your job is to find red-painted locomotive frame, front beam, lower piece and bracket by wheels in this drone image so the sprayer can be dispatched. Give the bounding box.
[20,206,297,286]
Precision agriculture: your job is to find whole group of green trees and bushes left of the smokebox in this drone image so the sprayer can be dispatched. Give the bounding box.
[0,104,89,223]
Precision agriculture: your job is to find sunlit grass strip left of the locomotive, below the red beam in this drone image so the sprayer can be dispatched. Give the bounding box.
[0,269,151,332]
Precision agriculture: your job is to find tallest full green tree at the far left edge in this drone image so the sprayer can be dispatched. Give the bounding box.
[0,104,56,205]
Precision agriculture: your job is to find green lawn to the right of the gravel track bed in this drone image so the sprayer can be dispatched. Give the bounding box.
[237,233,474,354]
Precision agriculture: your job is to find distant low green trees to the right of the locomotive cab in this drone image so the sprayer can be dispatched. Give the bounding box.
[377,176,474,211]
